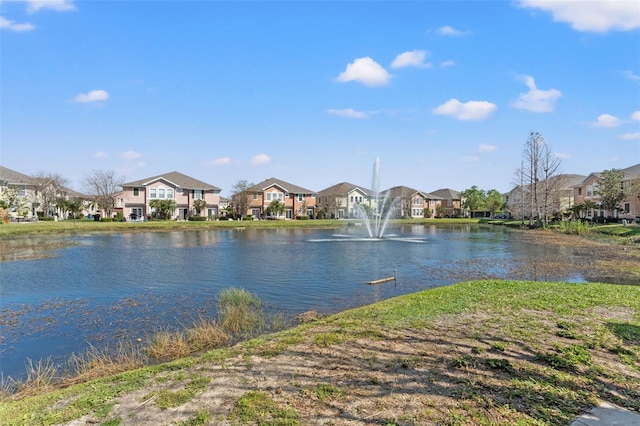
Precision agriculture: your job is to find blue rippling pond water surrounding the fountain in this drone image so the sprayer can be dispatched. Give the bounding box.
[0,225,584,378]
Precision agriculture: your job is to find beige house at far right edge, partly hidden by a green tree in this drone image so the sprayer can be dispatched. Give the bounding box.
[572,164,640,220]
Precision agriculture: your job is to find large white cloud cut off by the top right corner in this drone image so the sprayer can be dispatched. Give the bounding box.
[520,0,640,33]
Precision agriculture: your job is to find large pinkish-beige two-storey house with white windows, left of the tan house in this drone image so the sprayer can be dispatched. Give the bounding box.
[116,171,221,220]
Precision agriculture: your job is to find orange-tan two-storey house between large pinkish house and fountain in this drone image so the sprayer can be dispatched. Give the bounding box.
[246,178,316,219]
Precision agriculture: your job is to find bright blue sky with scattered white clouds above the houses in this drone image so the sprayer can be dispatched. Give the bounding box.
[0,0,640,195]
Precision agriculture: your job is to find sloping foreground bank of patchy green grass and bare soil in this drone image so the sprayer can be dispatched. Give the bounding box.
[0,281,640,425]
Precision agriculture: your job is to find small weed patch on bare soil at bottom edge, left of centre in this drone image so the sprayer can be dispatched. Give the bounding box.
[229,391,300,425]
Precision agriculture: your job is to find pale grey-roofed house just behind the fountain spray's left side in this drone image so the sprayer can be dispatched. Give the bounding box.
[316,182,376,219]
